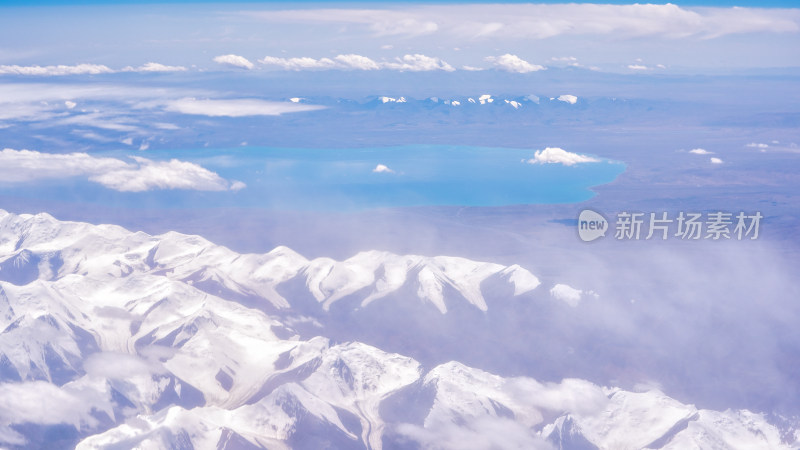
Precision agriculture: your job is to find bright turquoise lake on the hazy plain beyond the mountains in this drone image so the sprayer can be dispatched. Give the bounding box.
[10,145,625,211]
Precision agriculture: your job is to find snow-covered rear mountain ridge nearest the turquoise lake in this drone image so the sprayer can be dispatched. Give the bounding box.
[0,211,539,313]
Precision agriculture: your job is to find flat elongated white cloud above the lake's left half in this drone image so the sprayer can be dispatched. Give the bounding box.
[166,97,324,117]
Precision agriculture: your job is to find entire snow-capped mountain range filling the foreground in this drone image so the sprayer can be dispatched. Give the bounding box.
[0,212,800,449]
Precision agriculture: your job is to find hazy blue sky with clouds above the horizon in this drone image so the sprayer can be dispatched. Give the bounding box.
[0,2,800,73]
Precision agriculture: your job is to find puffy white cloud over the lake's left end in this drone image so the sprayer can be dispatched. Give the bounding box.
[0,148,244,192]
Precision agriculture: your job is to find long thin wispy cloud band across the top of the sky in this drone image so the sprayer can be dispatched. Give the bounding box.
[241,4,800,39]
